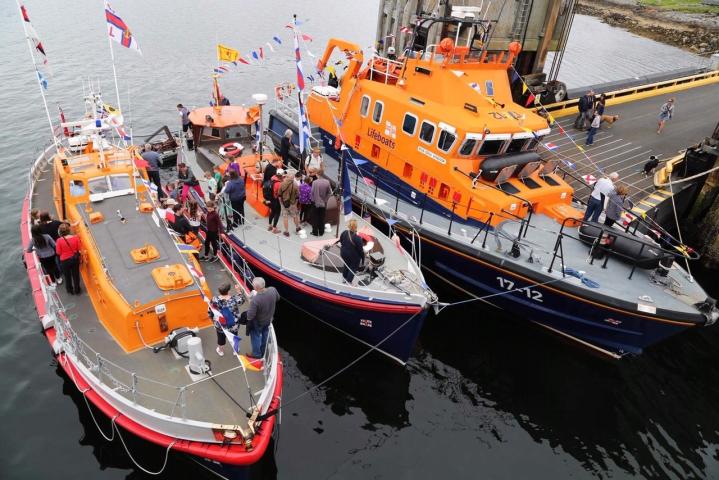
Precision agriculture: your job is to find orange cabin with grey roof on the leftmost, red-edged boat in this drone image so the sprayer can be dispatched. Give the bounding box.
[53,142,210,352]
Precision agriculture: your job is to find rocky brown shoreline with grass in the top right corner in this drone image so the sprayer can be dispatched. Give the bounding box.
[577,0,719,55]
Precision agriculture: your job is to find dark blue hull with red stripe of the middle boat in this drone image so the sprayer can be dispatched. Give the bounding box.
[223,235,427,364]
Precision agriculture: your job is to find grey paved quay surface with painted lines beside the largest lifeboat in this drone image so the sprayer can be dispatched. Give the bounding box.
[541,83,719,203]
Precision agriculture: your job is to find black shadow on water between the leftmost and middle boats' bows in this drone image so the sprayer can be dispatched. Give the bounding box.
[274,302,412,429]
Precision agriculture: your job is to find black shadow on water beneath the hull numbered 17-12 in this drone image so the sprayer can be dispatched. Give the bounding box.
[411,280,719,478]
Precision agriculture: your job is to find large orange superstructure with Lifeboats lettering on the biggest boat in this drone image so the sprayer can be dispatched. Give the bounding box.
[307,39,577,225]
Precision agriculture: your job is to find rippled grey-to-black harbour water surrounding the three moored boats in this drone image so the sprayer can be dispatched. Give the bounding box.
[0,0,719,479]
